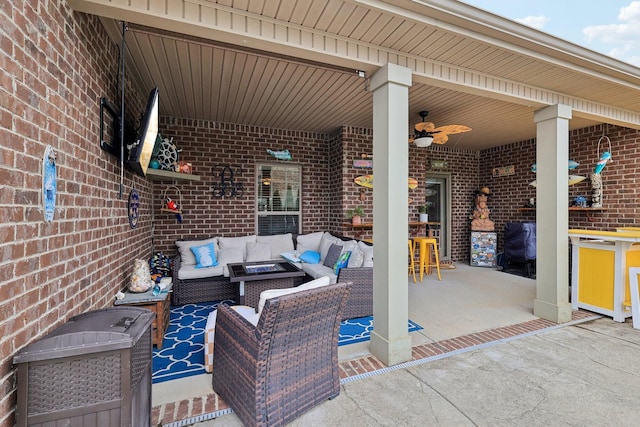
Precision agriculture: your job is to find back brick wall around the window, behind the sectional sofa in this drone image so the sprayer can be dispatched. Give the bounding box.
[150,117,333,256]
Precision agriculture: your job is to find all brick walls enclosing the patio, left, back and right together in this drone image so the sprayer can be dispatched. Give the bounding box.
[0,1,640,427]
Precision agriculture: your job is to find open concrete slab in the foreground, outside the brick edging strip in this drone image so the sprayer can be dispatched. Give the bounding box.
[195,318,640,427]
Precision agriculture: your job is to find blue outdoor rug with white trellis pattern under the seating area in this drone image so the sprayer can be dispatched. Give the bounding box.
[152,301,422,384]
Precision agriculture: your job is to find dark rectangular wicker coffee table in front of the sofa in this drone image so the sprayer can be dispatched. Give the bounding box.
[227,261,305,309]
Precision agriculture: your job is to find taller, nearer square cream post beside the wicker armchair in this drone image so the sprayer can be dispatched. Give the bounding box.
[370,64,411,366]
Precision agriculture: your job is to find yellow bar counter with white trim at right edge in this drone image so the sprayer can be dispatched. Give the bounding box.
[569,228,640,322]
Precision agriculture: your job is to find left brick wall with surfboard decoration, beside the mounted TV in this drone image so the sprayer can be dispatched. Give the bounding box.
[0,5,151,427]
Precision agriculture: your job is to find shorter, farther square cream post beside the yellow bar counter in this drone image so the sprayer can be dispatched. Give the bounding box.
[533,104,572,323]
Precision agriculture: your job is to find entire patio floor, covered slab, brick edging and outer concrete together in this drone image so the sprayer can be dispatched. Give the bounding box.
[153,264,640,426]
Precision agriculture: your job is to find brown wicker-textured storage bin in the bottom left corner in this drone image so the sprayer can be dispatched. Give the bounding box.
[13,307,154,427]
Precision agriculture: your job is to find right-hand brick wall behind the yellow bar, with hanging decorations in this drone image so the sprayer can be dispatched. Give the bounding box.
[479,125,640,256]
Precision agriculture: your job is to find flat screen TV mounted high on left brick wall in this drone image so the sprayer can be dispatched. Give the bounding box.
[126,87,158,176]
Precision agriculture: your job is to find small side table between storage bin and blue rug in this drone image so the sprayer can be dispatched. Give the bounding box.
[113,284,172,350]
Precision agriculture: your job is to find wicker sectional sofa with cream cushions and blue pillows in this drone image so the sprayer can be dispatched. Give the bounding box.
[171,232,373,319]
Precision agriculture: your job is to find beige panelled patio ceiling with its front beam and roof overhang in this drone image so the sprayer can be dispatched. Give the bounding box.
[69,0,640,149]
